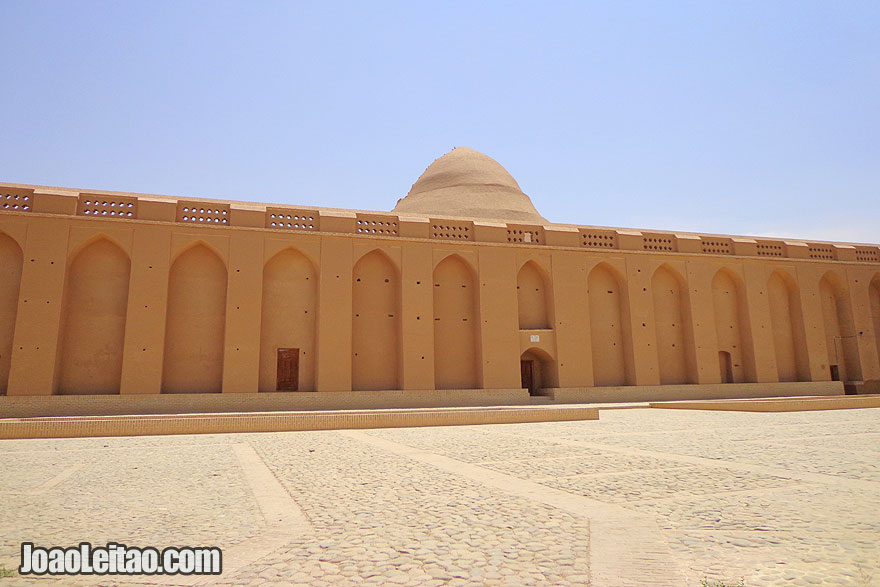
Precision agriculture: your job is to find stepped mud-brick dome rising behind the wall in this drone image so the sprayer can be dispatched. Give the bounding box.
[392,147,547,223]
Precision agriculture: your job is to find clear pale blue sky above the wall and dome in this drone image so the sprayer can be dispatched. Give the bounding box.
[0,0,880,243]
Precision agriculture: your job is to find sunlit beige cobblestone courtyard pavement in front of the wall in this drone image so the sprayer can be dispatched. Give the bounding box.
[0,409,880,587]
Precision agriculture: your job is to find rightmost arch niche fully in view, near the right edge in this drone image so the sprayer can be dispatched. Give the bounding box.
[819,271,862,381]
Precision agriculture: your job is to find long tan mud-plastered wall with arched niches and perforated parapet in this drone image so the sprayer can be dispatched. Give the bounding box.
[0,184,880,396]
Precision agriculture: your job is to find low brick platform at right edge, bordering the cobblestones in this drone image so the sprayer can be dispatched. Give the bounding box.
[648,395,880,412]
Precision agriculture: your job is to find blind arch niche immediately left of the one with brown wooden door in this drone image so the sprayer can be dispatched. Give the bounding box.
[162,242,227,393]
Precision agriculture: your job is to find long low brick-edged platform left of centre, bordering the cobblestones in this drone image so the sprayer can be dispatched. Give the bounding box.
[0,406,599,439]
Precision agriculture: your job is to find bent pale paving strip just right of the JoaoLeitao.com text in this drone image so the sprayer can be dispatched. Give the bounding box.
[126,444,314,585]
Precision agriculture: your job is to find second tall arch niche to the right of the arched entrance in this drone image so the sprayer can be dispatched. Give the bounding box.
[651,264,696,385]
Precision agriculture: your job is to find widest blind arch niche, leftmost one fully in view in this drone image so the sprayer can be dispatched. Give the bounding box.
[58,238,131,394]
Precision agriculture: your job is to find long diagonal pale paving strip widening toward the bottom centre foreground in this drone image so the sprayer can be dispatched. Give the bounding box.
[340,431,686,587]
